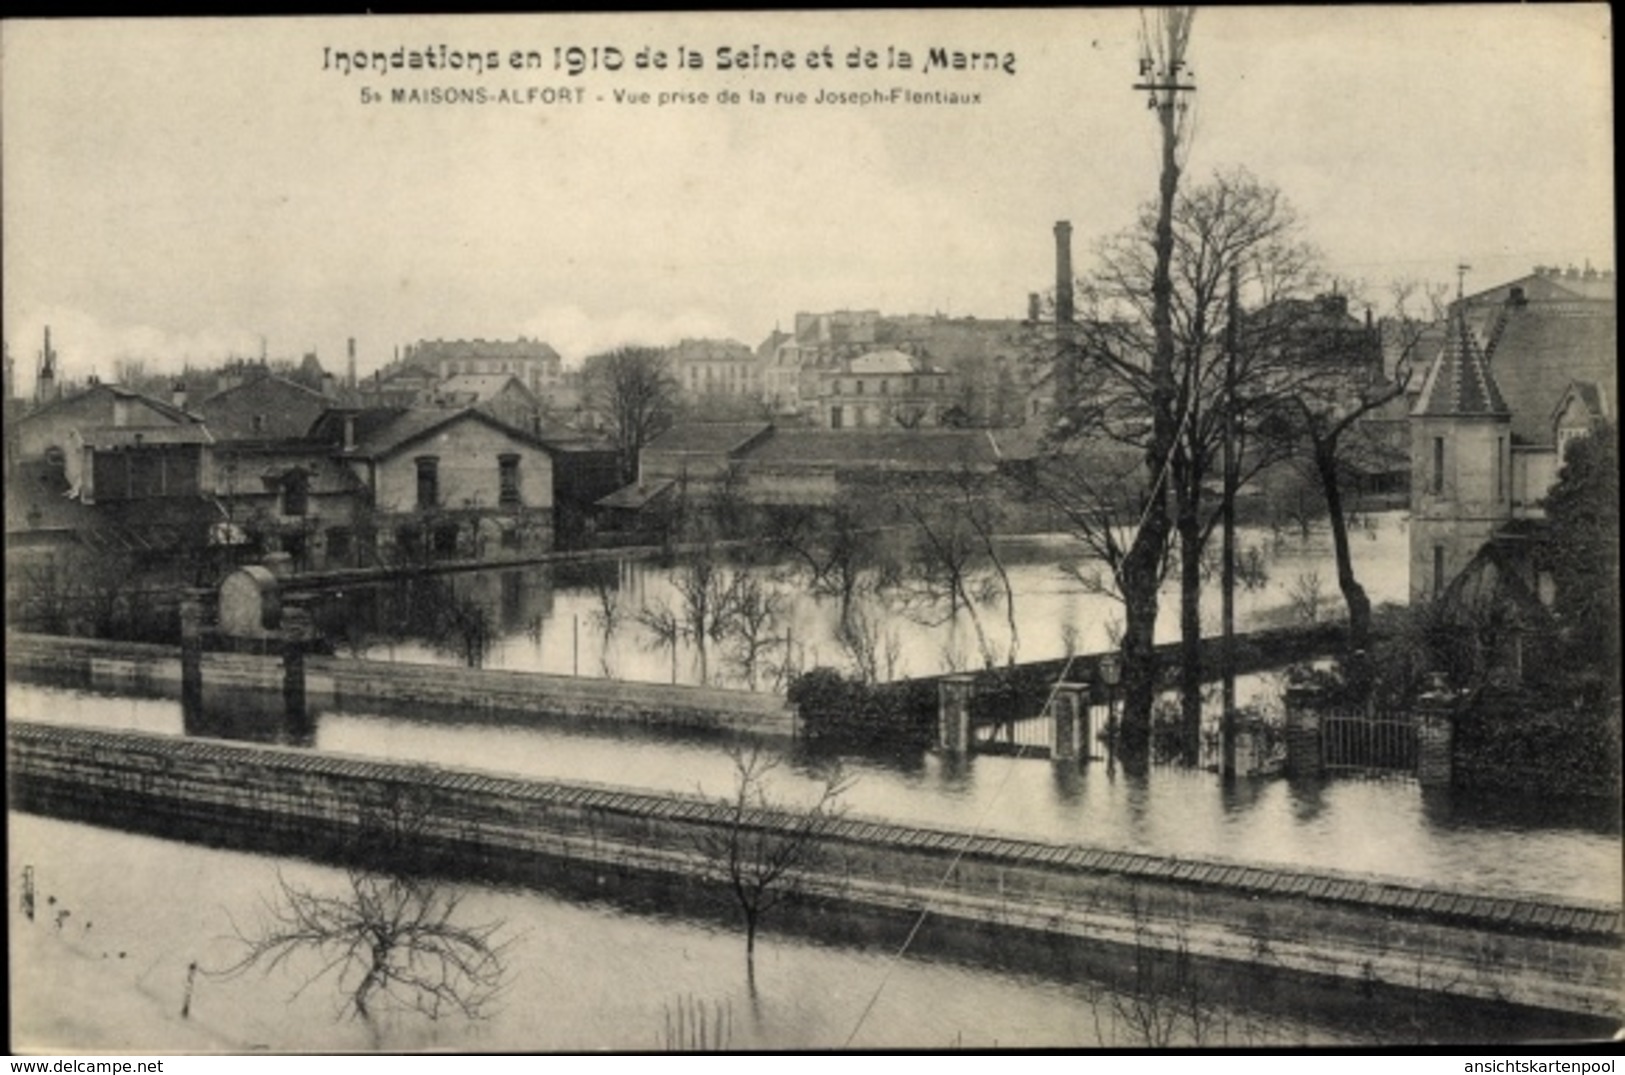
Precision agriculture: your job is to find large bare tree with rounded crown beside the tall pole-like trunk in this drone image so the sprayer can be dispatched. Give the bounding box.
[1082,169,1326,755]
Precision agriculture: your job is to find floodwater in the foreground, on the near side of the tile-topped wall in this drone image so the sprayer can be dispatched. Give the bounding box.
[8,815,1560,1052]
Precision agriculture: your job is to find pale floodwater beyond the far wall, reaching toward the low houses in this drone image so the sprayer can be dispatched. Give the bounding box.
[315,513,1409,685]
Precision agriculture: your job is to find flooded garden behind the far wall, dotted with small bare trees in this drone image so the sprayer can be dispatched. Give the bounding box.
[328,512,1409,689]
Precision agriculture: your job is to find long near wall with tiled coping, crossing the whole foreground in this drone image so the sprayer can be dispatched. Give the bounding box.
[7,723,1625,1018]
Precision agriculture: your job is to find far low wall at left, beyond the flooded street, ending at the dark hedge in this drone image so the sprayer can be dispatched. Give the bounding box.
[5,633,796,736]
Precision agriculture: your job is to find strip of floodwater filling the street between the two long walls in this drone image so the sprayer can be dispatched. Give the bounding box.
[7,682,1622,901]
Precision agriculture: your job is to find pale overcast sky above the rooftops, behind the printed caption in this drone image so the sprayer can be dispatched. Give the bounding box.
[0,5,1614,390]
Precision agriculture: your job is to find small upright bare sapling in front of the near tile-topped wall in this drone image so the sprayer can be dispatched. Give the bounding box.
[697,745,852,984]
